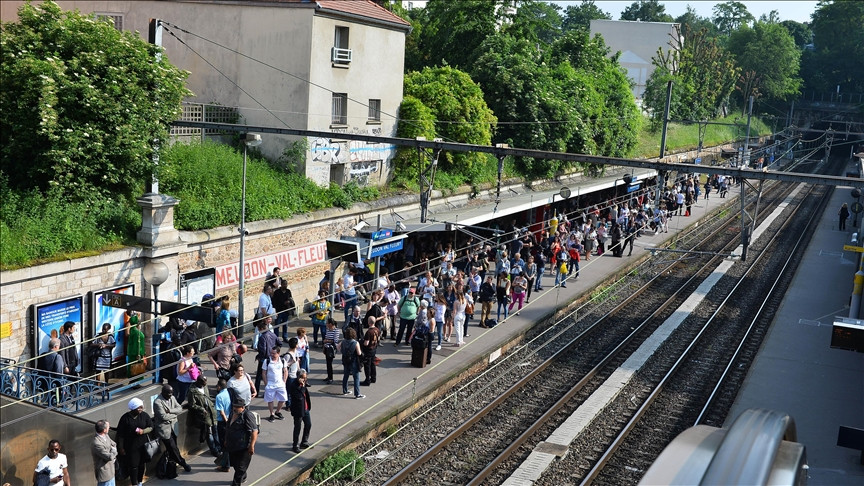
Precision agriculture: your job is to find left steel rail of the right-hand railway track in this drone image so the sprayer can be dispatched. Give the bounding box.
[580,180,818,485]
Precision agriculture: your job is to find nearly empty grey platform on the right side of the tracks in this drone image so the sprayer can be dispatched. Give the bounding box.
[725,181,864,485]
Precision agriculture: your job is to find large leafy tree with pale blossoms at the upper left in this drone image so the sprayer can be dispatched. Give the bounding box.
[0,1,191,200]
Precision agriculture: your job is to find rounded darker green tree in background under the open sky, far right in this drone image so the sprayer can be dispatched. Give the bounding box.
[727,22,801,101]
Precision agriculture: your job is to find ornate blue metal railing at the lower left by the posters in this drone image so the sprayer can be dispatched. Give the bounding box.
[0,358,111,413]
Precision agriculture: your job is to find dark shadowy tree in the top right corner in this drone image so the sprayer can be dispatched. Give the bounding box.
[802,1,864,93]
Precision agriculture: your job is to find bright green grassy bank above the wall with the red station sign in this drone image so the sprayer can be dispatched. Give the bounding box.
[159,142,378,230]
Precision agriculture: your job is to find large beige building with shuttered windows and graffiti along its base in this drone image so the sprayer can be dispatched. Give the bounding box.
[0,0,411,185]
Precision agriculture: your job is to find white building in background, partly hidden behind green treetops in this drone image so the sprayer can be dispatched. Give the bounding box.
[591,20,684,103]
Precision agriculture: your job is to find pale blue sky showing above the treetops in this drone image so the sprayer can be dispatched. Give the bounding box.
[554,0,819,22]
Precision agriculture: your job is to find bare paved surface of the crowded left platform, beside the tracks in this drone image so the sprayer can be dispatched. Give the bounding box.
[178,187,738,485]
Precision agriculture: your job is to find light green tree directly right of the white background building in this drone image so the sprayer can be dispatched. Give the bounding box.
[643,25,740,120]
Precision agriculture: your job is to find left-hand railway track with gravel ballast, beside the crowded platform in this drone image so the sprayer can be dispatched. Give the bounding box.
[314,160,840,484]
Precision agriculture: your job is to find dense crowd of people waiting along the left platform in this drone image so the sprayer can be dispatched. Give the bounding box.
[28,177,744,485]
